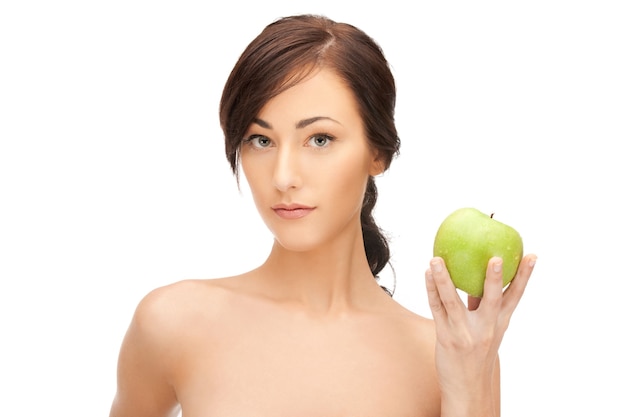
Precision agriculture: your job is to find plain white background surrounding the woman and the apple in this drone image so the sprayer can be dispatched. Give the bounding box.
[0,0,626,416]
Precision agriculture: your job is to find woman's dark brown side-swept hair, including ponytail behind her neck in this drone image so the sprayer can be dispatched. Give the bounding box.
[220,15,400,292]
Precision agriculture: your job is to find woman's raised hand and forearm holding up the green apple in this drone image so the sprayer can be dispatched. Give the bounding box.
[426,255,536,416]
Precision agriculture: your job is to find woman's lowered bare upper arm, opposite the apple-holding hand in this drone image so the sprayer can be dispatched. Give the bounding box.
[109,290,179,417]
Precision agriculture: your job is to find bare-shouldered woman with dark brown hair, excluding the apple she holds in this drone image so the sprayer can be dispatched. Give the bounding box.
[110,16,535,417]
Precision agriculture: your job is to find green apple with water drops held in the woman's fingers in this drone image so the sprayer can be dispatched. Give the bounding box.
[433,207,524,297]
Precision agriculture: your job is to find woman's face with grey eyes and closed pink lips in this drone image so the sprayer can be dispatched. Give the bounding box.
[241,69,383,251]
